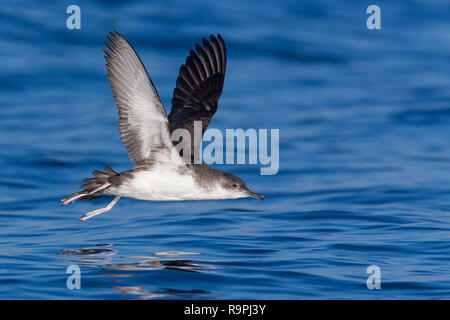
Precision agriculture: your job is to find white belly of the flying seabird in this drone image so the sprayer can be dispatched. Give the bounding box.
[108,168,214,201]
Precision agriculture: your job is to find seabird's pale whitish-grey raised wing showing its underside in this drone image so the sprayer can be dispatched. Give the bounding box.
[103,31,173,164]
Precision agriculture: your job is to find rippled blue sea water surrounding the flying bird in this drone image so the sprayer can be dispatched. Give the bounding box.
[0,0,450,299]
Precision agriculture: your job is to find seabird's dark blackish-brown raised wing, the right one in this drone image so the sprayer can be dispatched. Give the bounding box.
[169,35,227,160]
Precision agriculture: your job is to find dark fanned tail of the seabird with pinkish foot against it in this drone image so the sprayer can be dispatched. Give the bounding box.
[60,166,119,206]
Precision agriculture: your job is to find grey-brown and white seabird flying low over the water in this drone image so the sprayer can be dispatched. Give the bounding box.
[61,31,264,221]
